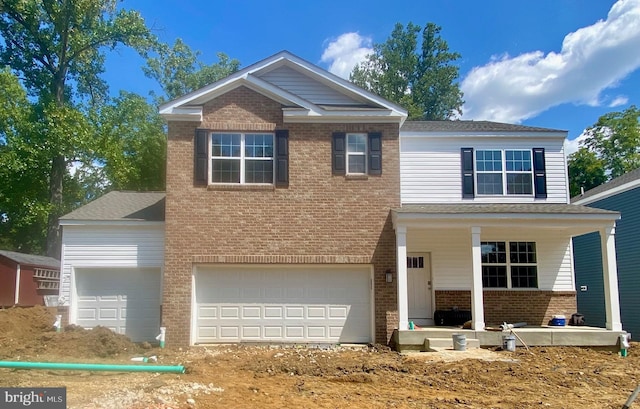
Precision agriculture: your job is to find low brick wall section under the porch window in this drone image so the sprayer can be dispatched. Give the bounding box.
[436,290,577,325]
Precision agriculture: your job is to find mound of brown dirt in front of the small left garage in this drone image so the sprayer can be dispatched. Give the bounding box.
[0,306,141,360]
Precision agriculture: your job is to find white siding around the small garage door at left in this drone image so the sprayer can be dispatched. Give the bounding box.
[60,224,164,305]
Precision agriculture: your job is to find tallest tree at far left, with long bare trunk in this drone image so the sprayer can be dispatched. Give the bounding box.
[0,0,154,256]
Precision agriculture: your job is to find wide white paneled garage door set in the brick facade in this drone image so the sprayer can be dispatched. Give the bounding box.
[194,265,372,343]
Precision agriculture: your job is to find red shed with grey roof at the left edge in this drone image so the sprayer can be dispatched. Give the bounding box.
[0,250,60,307]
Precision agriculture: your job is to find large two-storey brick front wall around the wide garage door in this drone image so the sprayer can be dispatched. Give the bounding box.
[162,87,400,345]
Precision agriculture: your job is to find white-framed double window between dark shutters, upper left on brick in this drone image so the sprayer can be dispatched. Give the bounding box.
[211,133,274,184]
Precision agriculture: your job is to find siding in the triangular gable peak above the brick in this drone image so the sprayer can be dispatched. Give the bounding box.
[260,67,361,105]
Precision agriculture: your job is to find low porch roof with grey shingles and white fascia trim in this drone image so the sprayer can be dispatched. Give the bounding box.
[392,203,620,235]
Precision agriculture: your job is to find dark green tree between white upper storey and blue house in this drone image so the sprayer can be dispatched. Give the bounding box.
[568,146,607,197]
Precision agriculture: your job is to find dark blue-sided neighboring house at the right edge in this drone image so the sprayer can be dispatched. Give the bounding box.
[571,169,640,335]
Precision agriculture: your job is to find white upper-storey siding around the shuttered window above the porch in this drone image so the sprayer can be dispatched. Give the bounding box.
[400,134,568,204]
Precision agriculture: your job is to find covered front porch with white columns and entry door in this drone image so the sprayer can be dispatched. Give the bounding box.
[393,203,622,345]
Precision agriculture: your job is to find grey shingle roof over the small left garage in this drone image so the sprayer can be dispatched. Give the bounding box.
[60,191,165,221]
